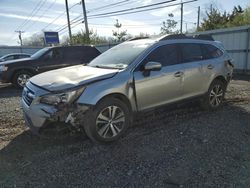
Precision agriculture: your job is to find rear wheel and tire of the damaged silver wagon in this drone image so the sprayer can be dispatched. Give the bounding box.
[201,80,226,110]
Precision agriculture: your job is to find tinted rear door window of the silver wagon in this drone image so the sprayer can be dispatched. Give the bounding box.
[180,43,203,63]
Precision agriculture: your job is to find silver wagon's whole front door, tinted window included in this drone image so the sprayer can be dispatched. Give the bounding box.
[134,44,184,110]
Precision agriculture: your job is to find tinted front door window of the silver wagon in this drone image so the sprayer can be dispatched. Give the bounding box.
[143,44,179,66]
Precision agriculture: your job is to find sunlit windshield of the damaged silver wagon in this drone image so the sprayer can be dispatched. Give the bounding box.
[88,41,152,69]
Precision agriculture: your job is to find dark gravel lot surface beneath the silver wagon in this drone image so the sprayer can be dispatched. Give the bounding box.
[0,78,250,187]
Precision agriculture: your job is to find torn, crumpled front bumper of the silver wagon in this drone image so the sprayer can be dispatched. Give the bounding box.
[21,82,90,134]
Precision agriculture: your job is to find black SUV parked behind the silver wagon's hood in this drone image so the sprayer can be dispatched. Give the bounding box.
[0,46,100,88]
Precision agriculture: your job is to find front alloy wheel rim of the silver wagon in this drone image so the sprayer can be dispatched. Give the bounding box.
[96,105,125,138]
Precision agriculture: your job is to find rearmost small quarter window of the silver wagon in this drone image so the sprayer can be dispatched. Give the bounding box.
[201,44,223,59]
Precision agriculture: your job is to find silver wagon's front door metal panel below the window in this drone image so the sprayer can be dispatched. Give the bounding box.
[134,65,183,110]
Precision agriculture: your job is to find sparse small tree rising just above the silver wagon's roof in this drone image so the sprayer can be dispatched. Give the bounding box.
[161,13,179,34]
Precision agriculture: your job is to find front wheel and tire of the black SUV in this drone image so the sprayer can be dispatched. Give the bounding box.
[12,70,33,89]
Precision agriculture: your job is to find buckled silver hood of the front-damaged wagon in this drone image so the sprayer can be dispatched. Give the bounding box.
[30,65,119,92]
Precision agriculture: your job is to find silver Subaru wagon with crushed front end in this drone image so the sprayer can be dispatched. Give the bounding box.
[22,35,233,142]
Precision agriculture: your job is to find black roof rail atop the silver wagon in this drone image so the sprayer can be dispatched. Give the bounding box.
[160,34,214,41]
